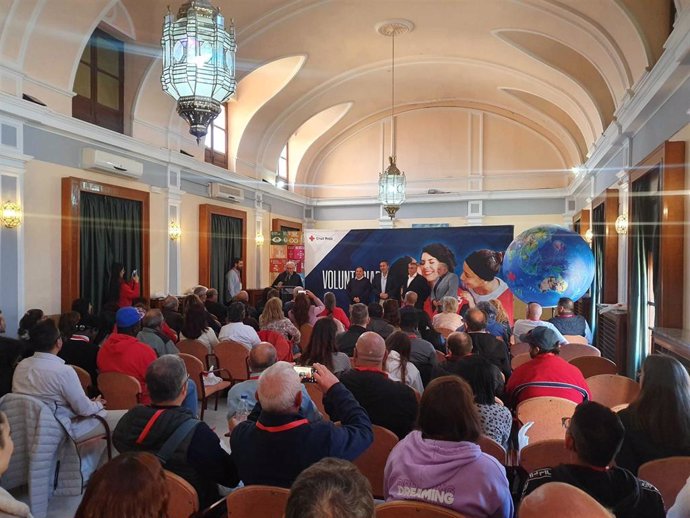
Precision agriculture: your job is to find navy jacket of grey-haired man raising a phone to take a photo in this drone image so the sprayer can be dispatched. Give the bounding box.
[230,383,374,488]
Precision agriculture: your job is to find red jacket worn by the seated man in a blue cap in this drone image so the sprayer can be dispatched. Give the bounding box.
[96,333,156,405]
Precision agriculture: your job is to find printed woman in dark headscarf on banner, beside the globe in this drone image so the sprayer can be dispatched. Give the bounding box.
[460,249,513,326]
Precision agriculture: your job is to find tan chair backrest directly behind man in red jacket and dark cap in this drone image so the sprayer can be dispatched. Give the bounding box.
[516,396,577,444]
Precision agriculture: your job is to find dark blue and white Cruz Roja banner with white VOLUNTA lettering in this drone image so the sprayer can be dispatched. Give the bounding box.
[304,225,513,312]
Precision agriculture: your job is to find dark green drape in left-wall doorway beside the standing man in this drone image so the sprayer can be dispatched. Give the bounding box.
[209,214,243,300]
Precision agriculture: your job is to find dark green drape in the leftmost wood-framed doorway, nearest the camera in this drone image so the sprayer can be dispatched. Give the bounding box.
[79,192,146,311]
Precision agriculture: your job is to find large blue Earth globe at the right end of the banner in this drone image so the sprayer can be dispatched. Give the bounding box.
[503,225,594,307]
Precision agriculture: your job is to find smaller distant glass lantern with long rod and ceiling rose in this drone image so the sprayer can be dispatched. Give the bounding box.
[376,20,414,219]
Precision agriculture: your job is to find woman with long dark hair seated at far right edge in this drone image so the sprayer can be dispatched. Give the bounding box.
[616,354,690,473]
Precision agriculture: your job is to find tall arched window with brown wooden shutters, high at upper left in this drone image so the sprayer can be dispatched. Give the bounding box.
[72,29,125,133]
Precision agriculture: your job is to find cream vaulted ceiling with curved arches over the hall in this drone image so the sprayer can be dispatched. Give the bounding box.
[0,0,672,199]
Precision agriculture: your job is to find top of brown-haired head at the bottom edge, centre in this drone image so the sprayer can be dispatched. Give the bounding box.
[285,458,375,518]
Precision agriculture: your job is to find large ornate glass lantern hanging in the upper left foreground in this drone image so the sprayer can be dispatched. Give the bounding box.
[161,0,237,143]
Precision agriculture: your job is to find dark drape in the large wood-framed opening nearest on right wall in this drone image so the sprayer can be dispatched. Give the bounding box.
[627,170,661,376]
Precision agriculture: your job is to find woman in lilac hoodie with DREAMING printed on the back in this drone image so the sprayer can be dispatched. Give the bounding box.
[384,376,513,518]
